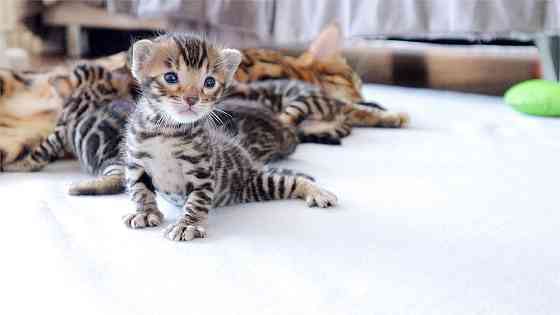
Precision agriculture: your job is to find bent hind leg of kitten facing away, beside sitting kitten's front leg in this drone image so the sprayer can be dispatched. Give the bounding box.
[68,163,125,196]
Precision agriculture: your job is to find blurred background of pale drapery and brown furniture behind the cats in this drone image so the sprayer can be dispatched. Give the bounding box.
[0,0,560,95]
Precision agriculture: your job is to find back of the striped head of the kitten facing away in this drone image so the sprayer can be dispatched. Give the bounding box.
[50,63,133,101]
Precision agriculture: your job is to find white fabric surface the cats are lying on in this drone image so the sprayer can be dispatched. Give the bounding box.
[0,86,560,315]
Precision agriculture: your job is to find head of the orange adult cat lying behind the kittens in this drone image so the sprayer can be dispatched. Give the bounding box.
[293,23,362,102]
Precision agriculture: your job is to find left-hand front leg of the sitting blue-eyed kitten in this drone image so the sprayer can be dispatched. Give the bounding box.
[123,162,163,229]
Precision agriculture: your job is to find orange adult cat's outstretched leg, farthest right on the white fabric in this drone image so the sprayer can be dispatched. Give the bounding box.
[346,102,410,128]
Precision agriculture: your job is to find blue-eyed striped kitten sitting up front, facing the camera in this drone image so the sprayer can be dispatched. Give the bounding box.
[124,34,336,241]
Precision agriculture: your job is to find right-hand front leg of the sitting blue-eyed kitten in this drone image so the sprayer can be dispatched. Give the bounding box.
[165,183,214,241]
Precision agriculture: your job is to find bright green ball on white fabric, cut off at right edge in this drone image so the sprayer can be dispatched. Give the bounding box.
[504,80,560,116]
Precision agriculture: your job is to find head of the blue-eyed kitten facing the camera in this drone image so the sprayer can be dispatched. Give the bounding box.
[129,34,241,123]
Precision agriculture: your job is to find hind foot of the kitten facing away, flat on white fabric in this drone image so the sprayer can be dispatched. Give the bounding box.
[68,174,125,196]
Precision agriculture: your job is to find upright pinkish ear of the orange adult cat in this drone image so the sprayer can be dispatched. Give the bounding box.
[307,22,342,60]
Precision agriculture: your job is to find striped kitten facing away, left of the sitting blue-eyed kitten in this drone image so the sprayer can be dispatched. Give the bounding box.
[2,64,132,195]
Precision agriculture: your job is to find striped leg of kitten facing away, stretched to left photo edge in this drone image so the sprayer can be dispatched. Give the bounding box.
[0,127,65,172]
